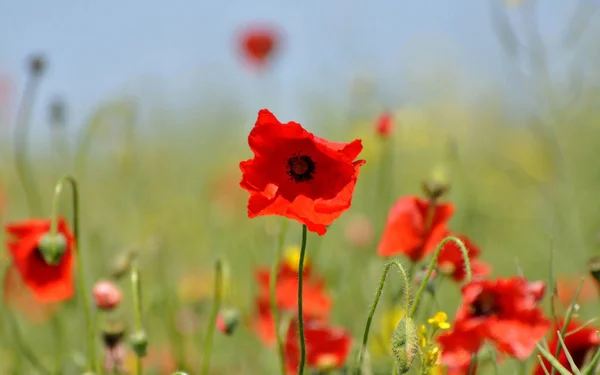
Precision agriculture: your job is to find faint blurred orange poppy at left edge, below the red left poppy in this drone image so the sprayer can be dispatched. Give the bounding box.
[2,265,59,324]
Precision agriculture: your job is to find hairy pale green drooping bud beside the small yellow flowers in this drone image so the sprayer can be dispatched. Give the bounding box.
[392,317,419,374]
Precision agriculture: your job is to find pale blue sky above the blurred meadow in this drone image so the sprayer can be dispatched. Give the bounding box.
[0,0,591,133]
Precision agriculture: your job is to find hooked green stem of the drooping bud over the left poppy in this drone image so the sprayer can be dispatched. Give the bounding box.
[50,176,100,373]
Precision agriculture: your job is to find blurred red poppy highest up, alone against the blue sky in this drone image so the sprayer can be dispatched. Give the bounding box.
[239,26,281,69]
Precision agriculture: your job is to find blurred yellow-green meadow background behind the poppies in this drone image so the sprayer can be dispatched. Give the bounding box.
[0,2,600,374]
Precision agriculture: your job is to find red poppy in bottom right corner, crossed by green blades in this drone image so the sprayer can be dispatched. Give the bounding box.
[533,320,600,375]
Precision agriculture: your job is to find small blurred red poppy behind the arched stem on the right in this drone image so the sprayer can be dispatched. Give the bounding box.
[438,233,492,281]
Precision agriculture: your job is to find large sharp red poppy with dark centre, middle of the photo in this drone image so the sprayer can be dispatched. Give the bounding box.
[240,109,365,235]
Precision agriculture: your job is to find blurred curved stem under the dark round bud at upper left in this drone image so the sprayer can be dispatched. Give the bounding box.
[13,73,42,216]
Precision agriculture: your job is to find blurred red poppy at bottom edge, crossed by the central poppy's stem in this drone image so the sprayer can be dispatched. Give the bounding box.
[284,320,352,374]
